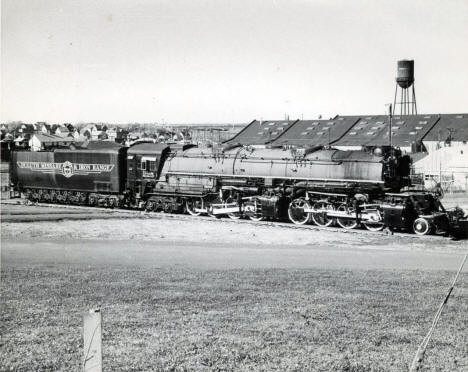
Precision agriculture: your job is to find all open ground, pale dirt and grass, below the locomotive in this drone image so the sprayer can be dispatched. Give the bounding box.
[0,207,468,371]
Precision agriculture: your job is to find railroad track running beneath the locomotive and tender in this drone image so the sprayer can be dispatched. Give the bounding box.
[1,199,447,240]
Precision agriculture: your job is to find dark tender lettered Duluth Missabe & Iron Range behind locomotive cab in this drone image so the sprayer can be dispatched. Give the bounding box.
[10,142,127,207]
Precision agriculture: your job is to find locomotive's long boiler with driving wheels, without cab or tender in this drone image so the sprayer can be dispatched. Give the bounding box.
[150,146,416,230]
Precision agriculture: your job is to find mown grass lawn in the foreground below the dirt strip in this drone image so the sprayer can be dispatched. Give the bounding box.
[0,264,468,371]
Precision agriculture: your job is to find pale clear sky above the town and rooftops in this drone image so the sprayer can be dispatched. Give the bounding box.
[1,0,468,123]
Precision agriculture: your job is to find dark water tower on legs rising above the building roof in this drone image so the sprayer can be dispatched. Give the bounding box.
[393,59,418,115]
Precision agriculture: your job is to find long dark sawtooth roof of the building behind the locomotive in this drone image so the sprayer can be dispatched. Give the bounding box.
[224,114,468,152]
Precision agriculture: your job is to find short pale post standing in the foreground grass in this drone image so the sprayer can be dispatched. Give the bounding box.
[83,308,102,372]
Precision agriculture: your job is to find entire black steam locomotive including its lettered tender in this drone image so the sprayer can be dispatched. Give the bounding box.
[10,142,463,235]
